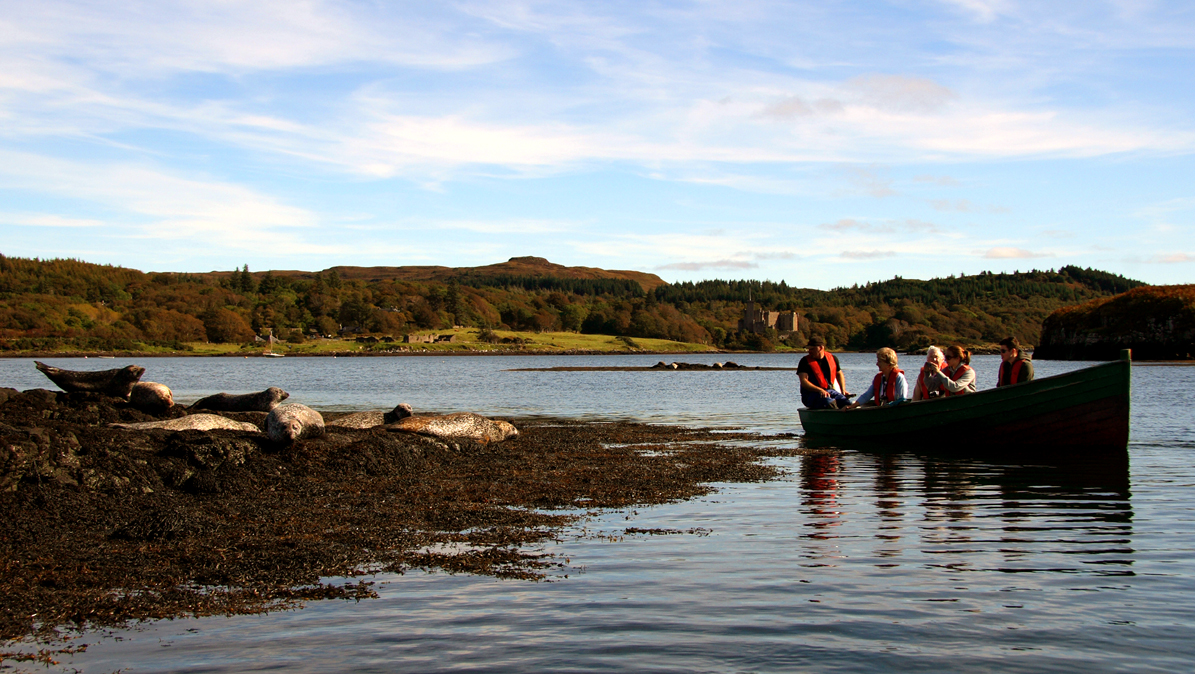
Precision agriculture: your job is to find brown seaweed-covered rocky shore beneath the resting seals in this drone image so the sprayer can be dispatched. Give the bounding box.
[0,388,791,662]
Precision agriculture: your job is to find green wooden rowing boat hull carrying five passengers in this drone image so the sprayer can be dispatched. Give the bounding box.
[799,350,1132,452]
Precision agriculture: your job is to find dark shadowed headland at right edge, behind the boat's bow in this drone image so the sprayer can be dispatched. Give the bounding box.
[1034,286,1195,361]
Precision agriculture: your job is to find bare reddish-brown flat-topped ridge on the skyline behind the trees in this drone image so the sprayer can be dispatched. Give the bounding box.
[229,256,664,293]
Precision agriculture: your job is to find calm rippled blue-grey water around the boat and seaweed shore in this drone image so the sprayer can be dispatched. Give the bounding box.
[0,354,1195,672]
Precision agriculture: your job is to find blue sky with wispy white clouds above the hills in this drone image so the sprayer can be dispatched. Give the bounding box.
[0,0,1195,288]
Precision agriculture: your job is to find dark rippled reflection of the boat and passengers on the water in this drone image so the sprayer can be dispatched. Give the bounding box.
[798,451,1135,575]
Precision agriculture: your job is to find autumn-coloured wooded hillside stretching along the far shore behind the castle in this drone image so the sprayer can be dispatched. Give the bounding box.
[0,256,1141,350]
